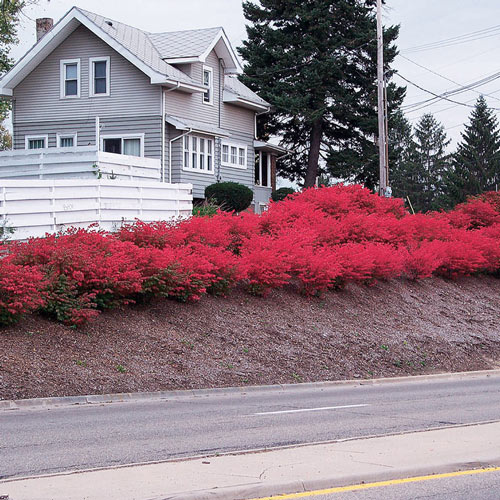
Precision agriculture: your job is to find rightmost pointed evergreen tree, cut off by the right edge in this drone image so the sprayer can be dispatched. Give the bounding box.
[446,96,500,206]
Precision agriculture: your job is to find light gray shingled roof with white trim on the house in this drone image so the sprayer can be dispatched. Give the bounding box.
[0,7,269,110]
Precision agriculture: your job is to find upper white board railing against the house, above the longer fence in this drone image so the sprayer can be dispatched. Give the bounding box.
[0,146,161,181]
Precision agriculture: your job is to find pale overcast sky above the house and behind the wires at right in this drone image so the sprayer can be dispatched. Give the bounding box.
[8,0,500,148]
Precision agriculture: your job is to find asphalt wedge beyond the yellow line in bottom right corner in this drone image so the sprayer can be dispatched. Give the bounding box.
[302,472,500,500]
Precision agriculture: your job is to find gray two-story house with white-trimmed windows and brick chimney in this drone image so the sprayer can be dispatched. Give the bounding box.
[0,7,284,212]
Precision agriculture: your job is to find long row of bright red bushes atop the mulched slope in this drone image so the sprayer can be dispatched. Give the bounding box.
[0,185,500,325]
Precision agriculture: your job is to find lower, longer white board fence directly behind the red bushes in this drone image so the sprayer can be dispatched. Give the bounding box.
[0,179,193,240]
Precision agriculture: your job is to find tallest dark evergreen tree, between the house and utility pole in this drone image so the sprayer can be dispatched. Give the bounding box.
[239,0,404,187]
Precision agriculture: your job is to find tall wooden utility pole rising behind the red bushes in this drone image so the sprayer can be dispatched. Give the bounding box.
[377,0,389,196]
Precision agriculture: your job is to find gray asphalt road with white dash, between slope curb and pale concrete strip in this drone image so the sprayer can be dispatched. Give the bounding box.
[0,376,500,478]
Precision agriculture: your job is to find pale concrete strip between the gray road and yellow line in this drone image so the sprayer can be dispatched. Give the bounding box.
[0,422,500,500]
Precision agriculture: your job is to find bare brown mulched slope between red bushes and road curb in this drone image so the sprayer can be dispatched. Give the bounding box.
[0,277,500,399]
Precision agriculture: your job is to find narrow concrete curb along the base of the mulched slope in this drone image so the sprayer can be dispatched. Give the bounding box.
[0,369,500,411]
